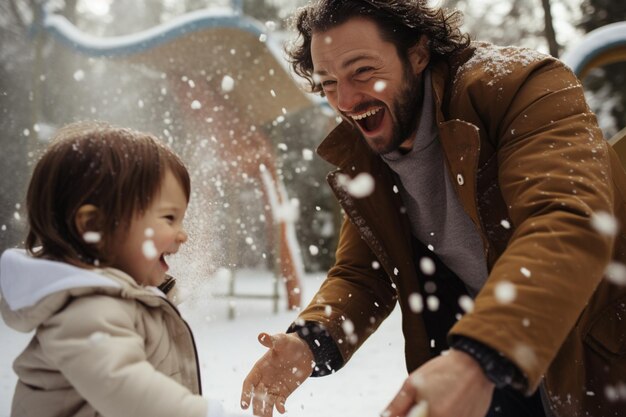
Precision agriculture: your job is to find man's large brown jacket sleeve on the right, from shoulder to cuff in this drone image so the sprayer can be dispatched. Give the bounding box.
[451,59,614,392]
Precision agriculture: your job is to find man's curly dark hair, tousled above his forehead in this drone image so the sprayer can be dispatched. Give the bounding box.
[287,0,470,93]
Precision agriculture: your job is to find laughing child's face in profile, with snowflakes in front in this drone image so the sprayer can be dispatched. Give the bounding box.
[113,170,187,286]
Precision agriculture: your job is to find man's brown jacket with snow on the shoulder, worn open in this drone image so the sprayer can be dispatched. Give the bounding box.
[300,44,626,417]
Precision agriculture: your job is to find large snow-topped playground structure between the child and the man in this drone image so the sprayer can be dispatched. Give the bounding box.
[35,6,316,317]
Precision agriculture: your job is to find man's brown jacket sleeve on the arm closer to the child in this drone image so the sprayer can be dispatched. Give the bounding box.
[296,214,396,365]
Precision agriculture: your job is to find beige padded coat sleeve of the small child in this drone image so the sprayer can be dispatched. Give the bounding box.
[36,296,210,417]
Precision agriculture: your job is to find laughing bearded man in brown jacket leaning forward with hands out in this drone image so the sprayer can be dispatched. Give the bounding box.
[242,0,626,417]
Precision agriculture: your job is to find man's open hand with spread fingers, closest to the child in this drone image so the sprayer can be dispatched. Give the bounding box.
[241,333,313,417]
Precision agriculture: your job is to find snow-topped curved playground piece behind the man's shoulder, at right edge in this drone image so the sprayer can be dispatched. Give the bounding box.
[562,22,626,163]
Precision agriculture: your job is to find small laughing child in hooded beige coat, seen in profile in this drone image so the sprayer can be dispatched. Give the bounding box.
[0,122,228,417]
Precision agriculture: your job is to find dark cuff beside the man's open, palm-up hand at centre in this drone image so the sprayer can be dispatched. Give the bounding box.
[287,321,343,377]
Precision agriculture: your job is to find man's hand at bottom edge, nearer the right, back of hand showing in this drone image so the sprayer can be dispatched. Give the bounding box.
[381,349,494,417]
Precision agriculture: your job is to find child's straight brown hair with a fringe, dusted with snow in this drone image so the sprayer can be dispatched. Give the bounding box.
[26,122,190,266]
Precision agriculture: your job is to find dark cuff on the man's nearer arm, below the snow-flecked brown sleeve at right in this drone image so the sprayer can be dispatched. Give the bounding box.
[450,336,528,392]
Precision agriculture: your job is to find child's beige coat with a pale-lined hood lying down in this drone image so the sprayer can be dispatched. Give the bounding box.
[0,250,212,417]
